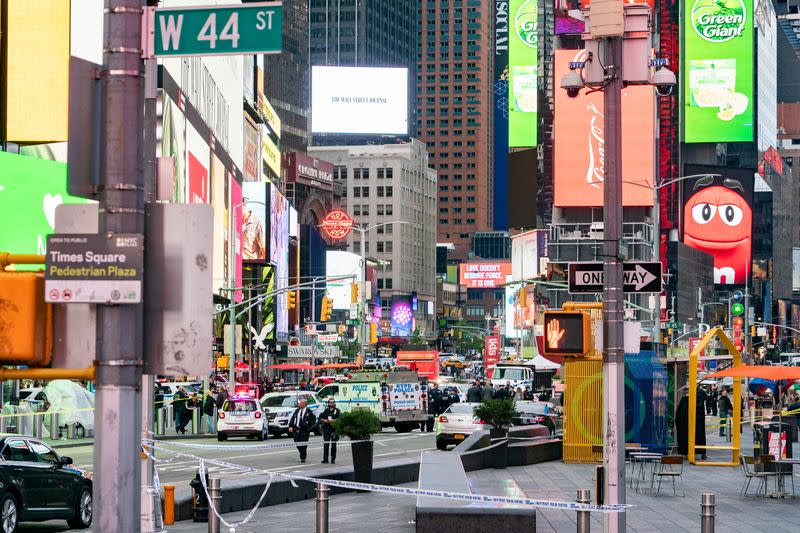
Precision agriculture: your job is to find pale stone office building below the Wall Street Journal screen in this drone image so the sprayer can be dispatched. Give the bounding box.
[309,140,436,331]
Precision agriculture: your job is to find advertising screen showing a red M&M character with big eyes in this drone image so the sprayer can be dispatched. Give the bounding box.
[682,165,754,285]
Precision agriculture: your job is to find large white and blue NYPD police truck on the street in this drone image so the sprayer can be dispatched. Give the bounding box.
[317,370,428,433]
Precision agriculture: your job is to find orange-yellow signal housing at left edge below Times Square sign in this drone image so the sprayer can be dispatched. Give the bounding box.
[0,272,51,366]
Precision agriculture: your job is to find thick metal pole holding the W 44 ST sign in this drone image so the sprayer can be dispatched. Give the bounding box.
[94,0,144,531]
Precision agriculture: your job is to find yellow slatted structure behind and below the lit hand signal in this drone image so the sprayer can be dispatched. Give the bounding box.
[563,302,603,463]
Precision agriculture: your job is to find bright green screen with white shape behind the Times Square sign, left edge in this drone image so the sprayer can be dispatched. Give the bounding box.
[0,152,89,264]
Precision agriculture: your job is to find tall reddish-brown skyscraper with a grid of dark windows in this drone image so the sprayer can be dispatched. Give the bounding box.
[416,0,494,259]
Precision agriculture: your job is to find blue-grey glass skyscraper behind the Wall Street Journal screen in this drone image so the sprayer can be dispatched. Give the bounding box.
[309,0,417,136]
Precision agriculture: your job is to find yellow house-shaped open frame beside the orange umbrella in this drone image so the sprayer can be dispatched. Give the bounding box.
[688,327,742,466]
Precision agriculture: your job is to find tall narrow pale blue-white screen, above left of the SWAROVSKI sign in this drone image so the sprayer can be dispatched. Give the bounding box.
[269,184,289,333]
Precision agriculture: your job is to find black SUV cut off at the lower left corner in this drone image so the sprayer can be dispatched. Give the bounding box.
[0,436,92,533]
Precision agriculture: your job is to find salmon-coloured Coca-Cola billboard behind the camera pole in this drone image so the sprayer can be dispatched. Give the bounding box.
[553,50,655,207]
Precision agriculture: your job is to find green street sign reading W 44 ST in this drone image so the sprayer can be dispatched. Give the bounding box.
[152,2,283,57]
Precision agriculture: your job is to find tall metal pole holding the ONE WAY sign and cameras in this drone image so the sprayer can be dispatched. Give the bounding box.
[603,35,625,533]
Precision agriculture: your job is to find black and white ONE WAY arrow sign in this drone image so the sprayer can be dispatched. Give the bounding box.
[568,262,662,294]
